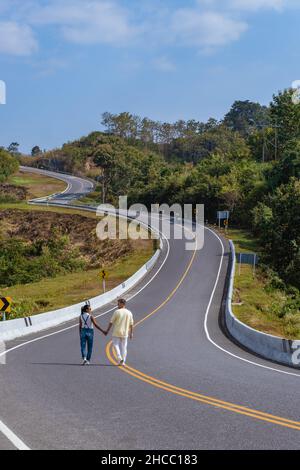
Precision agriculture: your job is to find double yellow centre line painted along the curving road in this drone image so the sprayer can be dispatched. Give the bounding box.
[106,237,300,431]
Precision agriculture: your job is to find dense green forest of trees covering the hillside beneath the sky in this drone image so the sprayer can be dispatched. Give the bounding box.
[22,90,300,296]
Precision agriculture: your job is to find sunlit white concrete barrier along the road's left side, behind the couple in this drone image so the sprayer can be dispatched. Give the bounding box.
[0,246,161,341]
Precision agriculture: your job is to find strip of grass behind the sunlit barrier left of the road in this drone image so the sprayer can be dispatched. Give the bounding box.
[1,243,153,319]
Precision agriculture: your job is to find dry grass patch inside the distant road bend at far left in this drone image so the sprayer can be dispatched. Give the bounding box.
[7,171,67,199]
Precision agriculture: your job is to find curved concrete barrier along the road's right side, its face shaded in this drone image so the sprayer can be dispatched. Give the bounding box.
[225,240,299,368]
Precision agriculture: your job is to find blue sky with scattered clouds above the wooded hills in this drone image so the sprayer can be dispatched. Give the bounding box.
[0,0,300,152]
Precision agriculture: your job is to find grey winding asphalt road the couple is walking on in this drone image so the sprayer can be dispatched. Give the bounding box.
[0,168,300,450]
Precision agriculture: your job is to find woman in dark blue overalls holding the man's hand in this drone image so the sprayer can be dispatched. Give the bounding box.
[79,304,106,366]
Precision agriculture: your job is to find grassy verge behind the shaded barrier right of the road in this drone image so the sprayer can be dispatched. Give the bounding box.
[213,228,300,339]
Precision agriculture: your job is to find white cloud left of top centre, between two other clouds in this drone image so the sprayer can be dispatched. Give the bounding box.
[30,0,137,45]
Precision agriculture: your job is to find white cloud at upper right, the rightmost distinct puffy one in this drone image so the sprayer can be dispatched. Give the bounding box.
[172,8,247,50]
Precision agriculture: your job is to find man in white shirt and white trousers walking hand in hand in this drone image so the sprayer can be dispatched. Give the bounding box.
[106,299,133,366]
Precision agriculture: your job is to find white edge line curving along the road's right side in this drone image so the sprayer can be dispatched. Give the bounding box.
[204,227,300,378]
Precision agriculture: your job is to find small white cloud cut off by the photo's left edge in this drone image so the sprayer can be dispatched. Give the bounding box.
[0,21,38,56]
